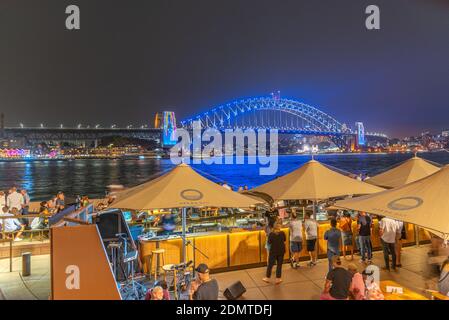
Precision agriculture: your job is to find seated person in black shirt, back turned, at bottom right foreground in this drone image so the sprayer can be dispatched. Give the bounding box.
[321,256,352,300]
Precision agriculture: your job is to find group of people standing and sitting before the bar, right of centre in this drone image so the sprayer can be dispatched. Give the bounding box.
[262,209,418,300]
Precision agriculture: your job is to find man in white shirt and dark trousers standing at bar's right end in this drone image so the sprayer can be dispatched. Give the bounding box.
[379,217,400,271]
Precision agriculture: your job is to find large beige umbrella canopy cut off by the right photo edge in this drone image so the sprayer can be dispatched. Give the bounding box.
[335,165,449,235]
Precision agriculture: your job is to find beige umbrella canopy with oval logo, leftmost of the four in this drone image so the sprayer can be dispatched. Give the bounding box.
[111,164,262,210]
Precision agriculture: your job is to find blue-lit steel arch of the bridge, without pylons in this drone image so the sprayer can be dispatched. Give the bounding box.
[181,96,351,135]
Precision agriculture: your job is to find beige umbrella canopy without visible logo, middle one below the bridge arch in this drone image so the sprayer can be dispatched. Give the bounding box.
[251,160,384,200]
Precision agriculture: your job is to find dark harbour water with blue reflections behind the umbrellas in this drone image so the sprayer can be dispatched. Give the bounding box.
[0,152,449,201]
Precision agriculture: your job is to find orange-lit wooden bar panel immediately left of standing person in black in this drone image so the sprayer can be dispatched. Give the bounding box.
[229,231,263,266]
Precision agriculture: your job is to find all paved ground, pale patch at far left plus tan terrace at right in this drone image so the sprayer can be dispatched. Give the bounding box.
[0,246,437,300]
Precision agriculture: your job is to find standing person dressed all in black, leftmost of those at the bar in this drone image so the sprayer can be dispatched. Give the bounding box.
[262,223,286,284]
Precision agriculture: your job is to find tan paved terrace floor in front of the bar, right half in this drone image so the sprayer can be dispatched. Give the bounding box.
[213,246,437,300]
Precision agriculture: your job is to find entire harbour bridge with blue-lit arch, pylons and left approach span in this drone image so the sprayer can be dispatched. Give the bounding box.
[0,94,387,146]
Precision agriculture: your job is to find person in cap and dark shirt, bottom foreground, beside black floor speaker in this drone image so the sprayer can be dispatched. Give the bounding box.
[189,263,218,300]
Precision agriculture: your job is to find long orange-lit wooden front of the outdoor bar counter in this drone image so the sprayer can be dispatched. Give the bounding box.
[139,219,430,272]
